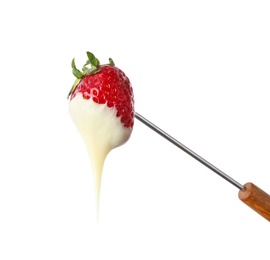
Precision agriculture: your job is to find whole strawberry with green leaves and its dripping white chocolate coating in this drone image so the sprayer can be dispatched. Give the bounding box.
[68,52,134,212]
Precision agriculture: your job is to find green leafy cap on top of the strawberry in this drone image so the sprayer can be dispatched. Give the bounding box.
[67,51,115,98]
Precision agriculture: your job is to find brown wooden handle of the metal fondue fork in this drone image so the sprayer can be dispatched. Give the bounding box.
[238,182,270,221]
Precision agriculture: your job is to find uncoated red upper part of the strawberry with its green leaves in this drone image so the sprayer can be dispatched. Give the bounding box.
[68,52,134,128]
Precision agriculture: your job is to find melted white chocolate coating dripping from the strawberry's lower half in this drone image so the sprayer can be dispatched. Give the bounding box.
[69,93,132,214]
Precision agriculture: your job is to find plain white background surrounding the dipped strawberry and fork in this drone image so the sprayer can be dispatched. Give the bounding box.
[0,0,270,260]
